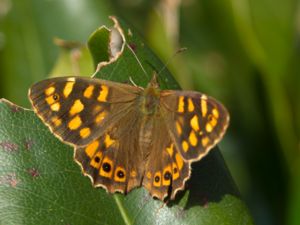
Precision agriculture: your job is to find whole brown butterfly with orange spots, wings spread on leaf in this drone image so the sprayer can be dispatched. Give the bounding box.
[29,75,229,200]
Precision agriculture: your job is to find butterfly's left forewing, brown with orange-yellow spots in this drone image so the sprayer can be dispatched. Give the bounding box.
[29,77,140,146]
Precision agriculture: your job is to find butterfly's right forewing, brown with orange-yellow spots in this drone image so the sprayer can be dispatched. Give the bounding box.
[161,91,229,161]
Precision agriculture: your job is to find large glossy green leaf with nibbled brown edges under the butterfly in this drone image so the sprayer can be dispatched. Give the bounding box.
[0,16,253,225]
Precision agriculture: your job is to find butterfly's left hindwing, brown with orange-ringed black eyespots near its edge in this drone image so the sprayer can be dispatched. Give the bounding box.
[75,104,144,193]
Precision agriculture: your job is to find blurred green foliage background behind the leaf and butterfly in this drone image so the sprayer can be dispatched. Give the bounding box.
[0,0,300,225]
